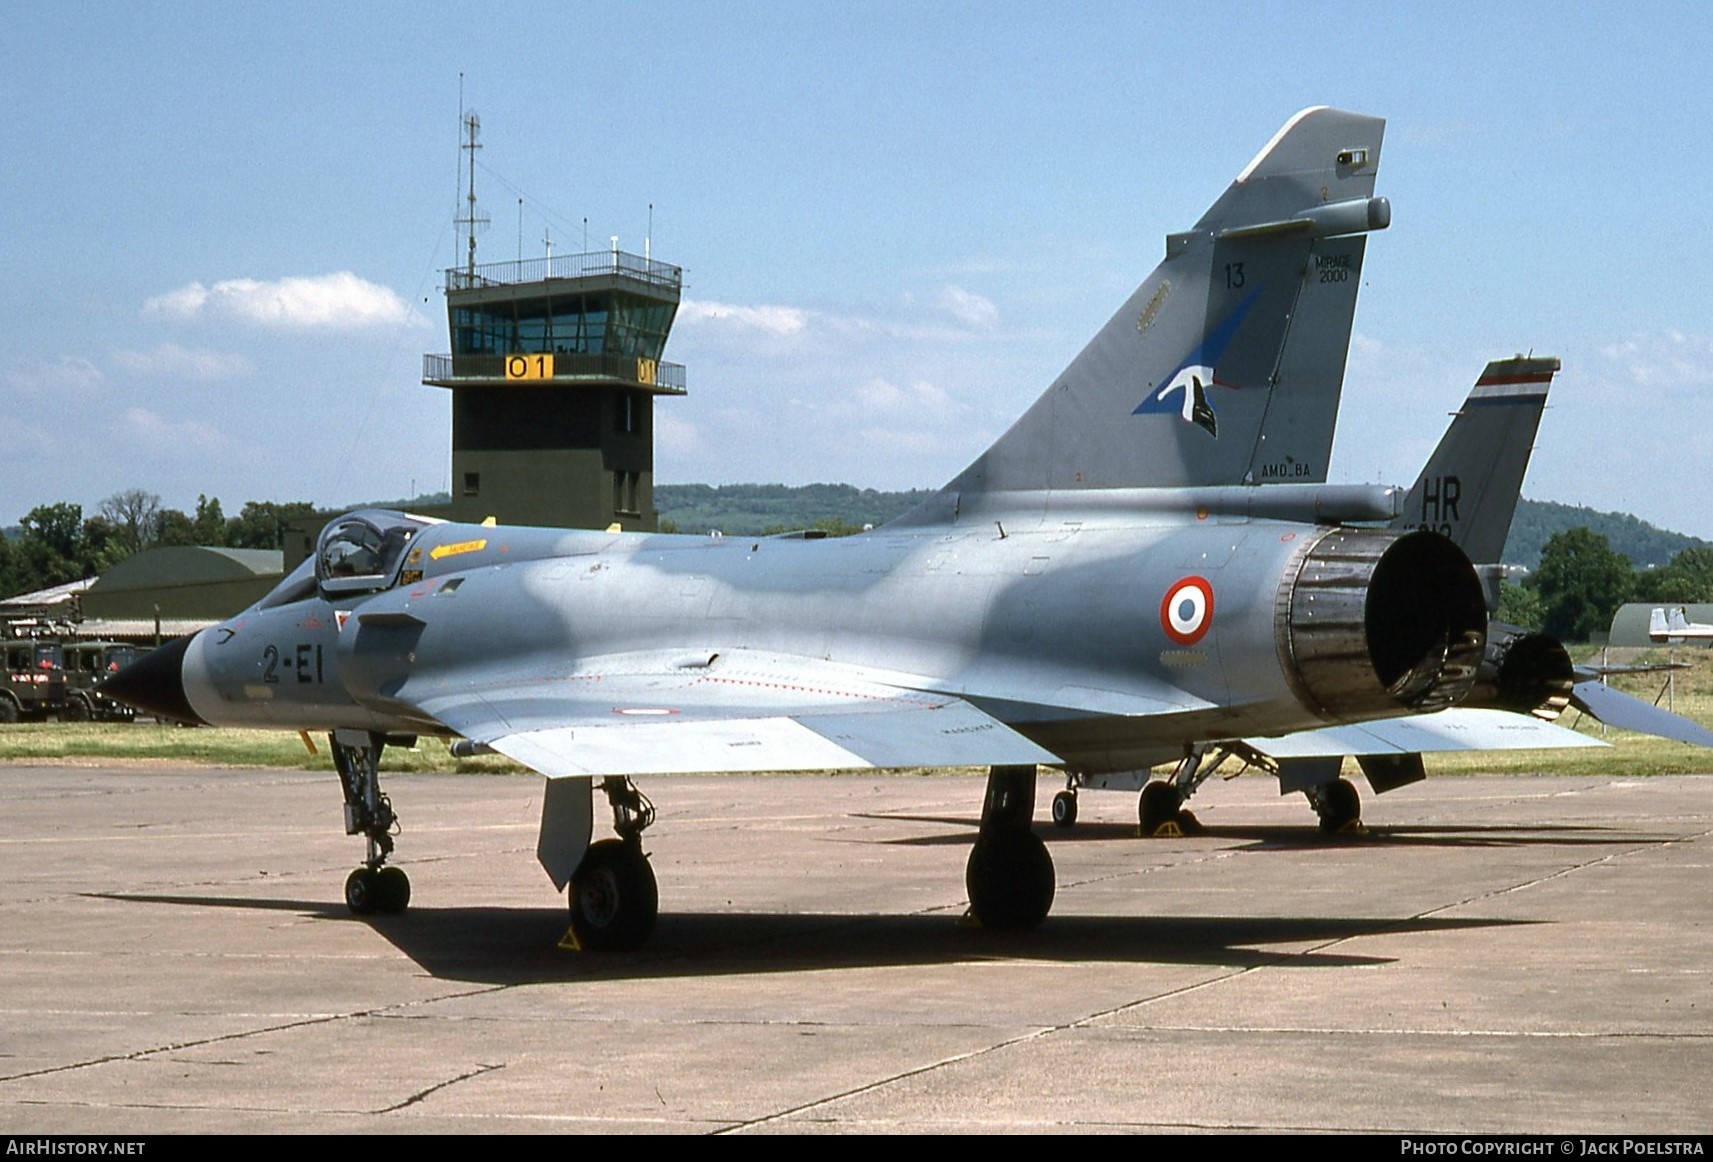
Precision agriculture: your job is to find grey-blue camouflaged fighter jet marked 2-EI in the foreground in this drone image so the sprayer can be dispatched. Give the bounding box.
[108,108,1579,948]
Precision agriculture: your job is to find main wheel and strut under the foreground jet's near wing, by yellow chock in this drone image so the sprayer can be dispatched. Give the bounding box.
[565,775,660,951]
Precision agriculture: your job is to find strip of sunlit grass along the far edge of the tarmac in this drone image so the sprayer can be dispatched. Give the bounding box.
[0,650,1713,776]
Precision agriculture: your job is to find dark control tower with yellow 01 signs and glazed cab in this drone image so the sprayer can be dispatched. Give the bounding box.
[423,245,685,531]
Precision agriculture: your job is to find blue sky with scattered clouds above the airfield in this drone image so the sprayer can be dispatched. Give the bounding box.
[0,2,1713,536]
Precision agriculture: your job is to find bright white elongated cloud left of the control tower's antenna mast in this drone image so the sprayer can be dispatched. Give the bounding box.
[142,271,421,331]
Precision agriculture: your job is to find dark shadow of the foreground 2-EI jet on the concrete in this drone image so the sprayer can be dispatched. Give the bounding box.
[86,893,1533,984]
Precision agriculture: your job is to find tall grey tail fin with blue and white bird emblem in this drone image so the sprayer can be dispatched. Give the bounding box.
[947,108,1391,494]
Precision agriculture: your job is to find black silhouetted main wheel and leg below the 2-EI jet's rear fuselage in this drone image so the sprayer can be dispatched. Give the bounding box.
[964,766,1053,929]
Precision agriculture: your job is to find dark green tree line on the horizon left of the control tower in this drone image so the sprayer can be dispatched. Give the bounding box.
[0,488,315,596]
